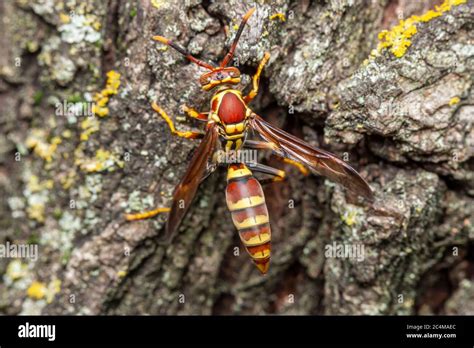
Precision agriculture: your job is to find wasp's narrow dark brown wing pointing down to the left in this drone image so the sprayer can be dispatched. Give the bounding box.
[163,123,219,241]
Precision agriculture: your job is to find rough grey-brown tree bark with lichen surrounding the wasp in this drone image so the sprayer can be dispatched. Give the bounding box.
[0,0,474,314]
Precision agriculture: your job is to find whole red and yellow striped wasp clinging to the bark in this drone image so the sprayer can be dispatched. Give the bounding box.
[126,8,373,274]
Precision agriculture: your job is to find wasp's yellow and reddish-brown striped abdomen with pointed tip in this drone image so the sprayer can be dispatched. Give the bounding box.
[226,164,271,274]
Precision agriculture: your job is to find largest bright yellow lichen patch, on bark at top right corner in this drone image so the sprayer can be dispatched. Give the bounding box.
[371,0,467,58]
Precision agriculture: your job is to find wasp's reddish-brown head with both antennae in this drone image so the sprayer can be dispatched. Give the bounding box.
[153,7,255,91]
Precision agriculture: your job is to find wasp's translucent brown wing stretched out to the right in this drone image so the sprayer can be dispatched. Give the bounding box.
[250,114,373,201]
